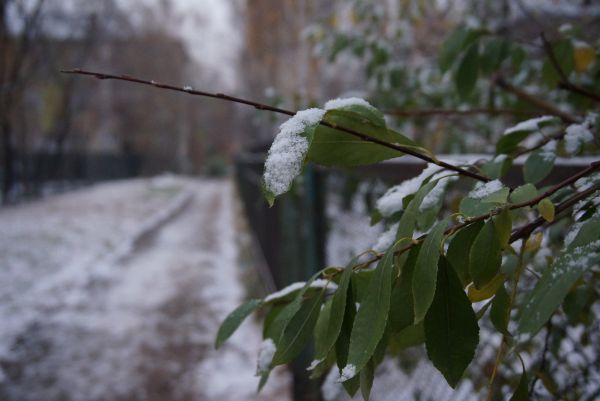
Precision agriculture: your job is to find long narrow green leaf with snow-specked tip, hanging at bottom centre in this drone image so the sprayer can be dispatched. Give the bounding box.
[345,247,394,379]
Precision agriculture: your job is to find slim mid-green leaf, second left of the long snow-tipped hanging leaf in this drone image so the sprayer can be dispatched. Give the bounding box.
[315,258,358,360]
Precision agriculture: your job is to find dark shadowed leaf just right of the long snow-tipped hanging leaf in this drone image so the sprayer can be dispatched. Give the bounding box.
[390,246,421,333]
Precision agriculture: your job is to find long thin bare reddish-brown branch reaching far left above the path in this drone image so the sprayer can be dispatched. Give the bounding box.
[61,69,491,182]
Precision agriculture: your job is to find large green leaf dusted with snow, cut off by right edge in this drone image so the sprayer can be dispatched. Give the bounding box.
[518,241,600,335]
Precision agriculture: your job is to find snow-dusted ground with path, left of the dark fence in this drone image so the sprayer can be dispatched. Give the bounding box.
[0,176,290,401]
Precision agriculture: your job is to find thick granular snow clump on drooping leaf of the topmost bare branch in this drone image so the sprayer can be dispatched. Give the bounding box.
[263,108,325,196]
